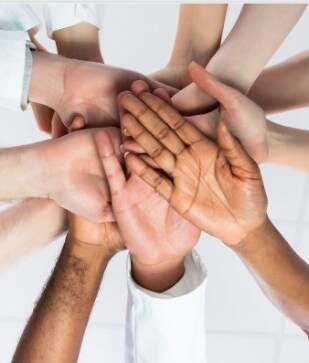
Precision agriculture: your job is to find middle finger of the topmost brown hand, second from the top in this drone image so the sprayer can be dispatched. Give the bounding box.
[121,93,185,155]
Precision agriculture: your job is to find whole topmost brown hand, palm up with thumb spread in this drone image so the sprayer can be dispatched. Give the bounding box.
[121,93,267,246]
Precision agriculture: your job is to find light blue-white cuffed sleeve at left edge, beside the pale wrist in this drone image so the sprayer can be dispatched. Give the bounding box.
[0,30,33,111]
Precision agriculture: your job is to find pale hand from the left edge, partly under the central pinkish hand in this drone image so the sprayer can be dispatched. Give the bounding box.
[36,128,121,223]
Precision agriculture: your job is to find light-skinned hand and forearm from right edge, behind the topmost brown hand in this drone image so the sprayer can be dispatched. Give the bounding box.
[185,61,309,172]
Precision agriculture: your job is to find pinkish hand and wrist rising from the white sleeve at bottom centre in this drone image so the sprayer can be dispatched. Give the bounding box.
[96,133,200,291]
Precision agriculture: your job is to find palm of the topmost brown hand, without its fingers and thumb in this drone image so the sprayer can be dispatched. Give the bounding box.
[170,140,264,245]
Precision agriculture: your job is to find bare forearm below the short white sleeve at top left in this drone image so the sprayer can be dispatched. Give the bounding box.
[53,23,103,63]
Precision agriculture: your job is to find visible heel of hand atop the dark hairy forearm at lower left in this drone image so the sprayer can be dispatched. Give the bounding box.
[69,213,125,255]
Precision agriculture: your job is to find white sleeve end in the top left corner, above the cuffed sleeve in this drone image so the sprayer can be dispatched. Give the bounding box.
[0,4,41,33]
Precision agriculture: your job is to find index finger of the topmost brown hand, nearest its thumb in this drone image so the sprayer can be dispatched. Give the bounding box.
[139,92,203,145]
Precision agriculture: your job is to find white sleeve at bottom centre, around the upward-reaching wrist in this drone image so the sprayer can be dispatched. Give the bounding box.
[126,251,207,363]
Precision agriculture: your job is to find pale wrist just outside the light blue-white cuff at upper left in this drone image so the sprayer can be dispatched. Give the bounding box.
[28,51,68,109]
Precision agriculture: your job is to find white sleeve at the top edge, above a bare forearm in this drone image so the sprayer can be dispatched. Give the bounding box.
[43,3,104,39]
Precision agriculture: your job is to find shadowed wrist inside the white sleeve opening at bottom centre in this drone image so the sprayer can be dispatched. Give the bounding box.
[131,255,185,292]
